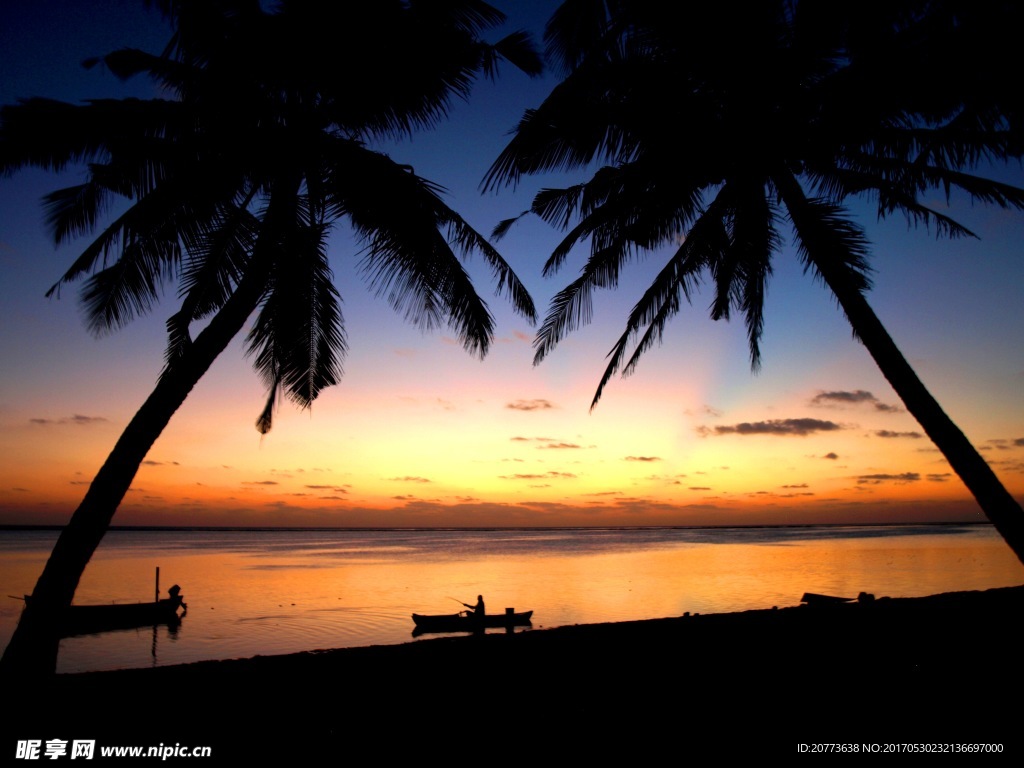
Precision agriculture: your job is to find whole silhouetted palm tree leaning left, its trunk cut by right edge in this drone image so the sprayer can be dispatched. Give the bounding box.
[484,0,1024,561]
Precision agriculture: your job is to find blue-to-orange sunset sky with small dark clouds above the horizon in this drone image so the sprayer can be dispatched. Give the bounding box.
[0,0,1024,526]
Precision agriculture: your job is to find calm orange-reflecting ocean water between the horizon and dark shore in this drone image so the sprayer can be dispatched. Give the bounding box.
[0,525,1024,672]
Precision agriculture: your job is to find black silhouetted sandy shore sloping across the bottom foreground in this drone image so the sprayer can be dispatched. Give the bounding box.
[9,587,1024,765]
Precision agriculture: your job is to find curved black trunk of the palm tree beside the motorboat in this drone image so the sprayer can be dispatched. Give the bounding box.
[0,268,266,678]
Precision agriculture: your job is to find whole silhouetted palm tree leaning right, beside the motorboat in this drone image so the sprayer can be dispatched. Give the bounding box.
[0,0,540,675]
